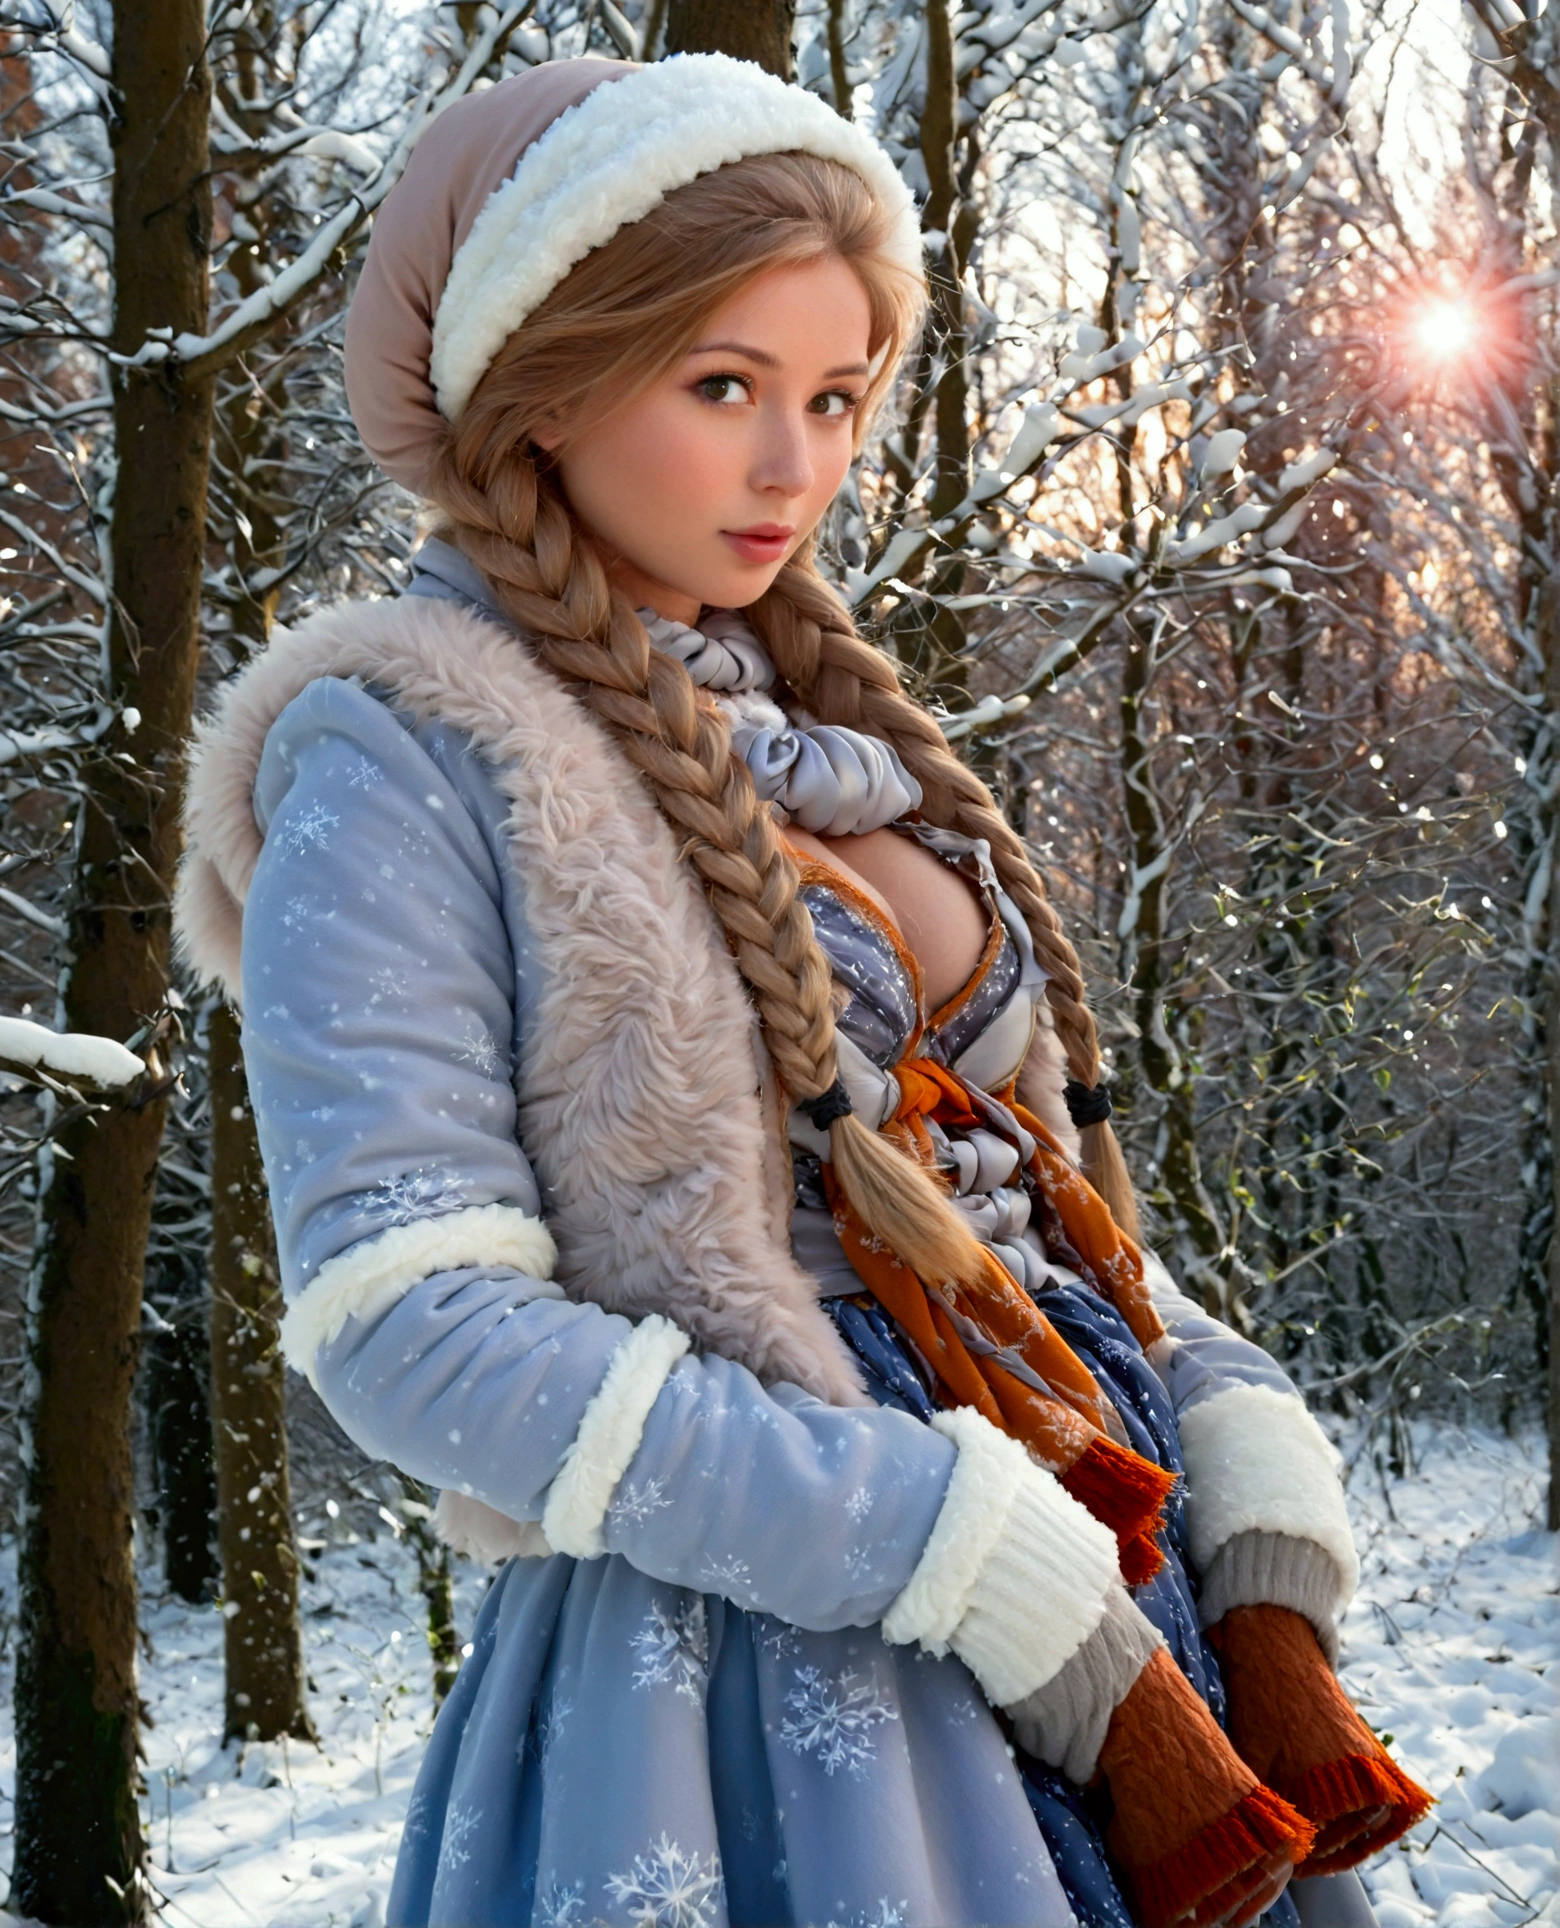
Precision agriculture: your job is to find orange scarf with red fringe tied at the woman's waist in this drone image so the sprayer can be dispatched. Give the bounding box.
[823,1058,1174,1585]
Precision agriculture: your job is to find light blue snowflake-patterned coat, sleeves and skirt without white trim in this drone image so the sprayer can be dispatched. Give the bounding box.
[243,562,1372,1928]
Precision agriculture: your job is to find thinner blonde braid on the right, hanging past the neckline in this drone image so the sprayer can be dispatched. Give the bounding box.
[750,557,1138,1238]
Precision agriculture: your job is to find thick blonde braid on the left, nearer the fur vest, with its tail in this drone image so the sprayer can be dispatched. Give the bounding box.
[428,451,983,1280]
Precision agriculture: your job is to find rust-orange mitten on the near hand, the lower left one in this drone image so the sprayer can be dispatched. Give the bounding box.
[1099,1648,1313,1928]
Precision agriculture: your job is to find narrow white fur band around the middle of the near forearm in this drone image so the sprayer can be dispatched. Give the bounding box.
[542,1313,688,1560]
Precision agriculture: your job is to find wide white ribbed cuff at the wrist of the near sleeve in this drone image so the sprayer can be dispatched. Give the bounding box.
[883,1407,1120,1706]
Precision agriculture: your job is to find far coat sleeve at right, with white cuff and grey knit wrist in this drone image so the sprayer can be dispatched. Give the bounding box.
[1143,1251,1359,1660]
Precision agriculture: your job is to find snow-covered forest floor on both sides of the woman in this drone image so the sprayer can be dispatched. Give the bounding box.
[0,1427,1560,1928]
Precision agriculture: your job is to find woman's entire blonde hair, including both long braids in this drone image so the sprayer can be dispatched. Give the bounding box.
[428,154,1132,1280]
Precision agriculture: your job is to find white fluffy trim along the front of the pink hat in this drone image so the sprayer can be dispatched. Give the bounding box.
[430,54,922,422]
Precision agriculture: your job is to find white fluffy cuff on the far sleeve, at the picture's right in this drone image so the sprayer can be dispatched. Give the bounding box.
[1178,1386,1359,1606]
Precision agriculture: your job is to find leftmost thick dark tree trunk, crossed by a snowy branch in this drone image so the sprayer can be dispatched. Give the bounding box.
[10,0,212,1928]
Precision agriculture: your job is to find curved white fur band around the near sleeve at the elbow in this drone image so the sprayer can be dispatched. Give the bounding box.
[282,1205,563,1392]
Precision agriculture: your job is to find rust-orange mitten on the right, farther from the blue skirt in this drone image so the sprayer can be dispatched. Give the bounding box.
[1211,1606,1431,1876]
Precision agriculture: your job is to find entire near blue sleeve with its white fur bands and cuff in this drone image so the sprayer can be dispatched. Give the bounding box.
[243,679,1116,1700]
